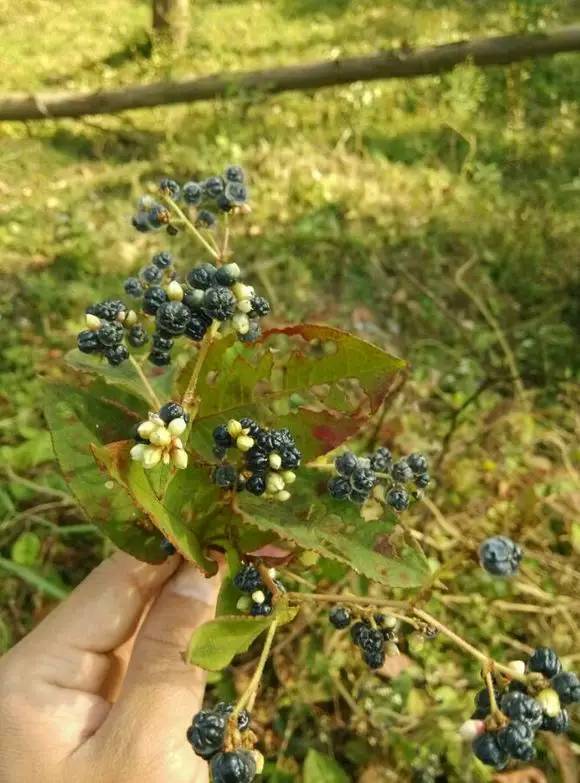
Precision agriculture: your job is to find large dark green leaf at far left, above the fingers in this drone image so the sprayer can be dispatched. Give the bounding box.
[45,384,166,563]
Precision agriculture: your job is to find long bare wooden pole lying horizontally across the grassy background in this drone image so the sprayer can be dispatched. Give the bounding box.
[0,25,580,121]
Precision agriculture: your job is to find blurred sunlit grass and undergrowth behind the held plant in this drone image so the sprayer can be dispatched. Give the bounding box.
[0,0,580,783]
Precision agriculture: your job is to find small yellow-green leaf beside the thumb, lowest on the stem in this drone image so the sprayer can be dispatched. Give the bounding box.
[185,599,298,672]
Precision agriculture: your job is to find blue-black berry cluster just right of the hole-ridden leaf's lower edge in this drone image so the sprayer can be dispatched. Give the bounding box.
[328,446,430,511]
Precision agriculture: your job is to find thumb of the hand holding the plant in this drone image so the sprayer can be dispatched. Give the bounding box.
[82,564,221,781]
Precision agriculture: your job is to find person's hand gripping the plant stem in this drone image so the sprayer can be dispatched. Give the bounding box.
[0,553,219,783]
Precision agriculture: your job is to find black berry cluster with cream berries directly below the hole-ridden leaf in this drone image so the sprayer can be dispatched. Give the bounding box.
[213,417,302,502]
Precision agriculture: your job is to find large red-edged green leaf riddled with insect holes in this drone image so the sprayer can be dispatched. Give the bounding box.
[184,324,406,460]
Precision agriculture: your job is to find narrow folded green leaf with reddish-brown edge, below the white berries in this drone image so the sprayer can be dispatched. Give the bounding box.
[93,441,217,574]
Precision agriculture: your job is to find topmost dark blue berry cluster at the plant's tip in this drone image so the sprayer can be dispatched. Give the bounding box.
[131,166,249,234]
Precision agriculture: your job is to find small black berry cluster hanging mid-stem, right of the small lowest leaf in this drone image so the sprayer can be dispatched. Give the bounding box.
[329,606,399,669]
